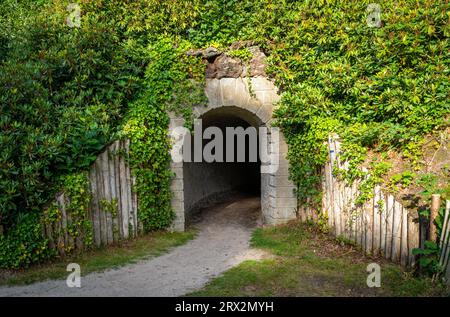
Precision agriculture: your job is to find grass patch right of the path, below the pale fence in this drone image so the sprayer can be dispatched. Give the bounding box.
[189,222,449,296]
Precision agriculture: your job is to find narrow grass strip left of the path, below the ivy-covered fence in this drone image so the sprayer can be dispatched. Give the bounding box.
[0,230,195,285]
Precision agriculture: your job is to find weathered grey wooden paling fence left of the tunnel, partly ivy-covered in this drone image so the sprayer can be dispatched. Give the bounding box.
[45,140,139,254]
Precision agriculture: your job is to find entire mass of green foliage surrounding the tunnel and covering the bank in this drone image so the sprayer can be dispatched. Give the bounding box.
[0,0,450,266]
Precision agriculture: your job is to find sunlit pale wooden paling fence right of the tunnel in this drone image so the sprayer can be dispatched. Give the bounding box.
[299,136,421,267]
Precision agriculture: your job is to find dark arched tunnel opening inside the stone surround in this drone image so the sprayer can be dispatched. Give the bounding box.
[183,107,261,223]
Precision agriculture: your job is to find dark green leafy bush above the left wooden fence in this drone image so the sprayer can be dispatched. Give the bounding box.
[0,1,141,227]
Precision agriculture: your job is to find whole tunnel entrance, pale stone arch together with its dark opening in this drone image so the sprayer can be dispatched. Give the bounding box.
[169,76,298,231]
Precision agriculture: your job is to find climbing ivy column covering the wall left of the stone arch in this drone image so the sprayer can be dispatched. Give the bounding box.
[123,39,206,231]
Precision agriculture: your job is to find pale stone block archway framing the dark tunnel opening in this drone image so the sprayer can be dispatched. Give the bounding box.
[169,76,297,231]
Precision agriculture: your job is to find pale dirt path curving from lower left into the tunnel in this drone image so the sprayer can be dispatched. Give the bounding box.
[0,197,265,296]
